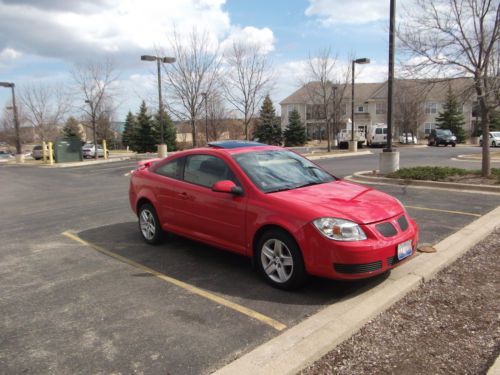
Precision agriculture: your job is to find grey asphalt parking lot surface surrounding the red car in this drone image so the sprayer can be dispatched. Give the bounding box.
[0,153,500,374]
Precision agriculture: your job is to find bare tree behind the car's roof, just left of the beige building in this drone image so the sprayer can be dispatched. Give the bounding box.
[223,42,272,140]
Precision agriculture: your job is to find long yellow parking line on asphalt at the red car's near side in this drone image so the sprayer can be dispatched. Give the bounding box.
[62,231,286,331]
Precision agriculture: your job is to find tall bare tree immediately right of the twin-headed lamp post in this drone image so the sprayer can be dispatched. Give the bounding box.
[164,29,221,147]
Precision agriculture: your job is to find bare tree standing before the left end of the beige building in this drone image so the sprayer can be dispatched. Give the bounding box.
[306,48,351,152]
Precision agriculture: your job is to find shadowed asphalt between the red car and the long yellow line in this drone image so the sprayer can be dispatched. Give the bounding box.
[78,222,388,323]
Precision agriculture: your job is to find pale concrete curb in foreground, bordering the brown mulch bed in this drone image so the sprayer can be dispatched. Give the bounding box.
[215,207,500,375]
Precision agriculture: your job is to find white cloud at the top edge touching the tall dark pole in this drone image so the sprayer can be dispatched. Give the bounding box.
[305,0,389,26]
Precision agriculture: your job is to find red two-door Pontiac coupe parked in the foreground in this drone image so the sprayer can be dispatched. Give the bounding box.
[129,141,418,289]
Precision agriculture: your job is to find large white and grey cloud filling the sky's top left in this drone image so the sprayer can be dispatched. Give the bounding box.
[0,0,231,61]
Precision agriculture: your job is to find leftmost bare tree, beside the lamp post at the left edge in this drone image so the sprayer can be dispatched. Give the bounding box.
[21,82,70,141]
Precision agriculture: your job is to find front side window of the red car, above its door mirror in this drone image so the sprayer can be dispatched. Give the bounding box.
[184,155,239,188]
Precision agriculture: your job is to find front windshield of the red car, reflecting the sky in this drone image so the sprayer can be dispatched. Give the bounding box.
[233,150,335,193]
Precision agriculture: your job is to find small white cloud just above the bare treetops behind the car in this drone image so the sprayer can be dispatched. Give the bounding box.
[221,26,275,55]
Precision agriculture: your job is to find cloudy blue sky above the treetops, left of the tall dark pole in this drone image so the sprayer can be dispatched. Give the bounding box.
[0,0,398,120]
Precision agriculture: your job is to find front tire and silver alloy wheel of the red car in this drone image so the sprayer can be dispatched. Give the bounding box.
[256,229,307,290]
